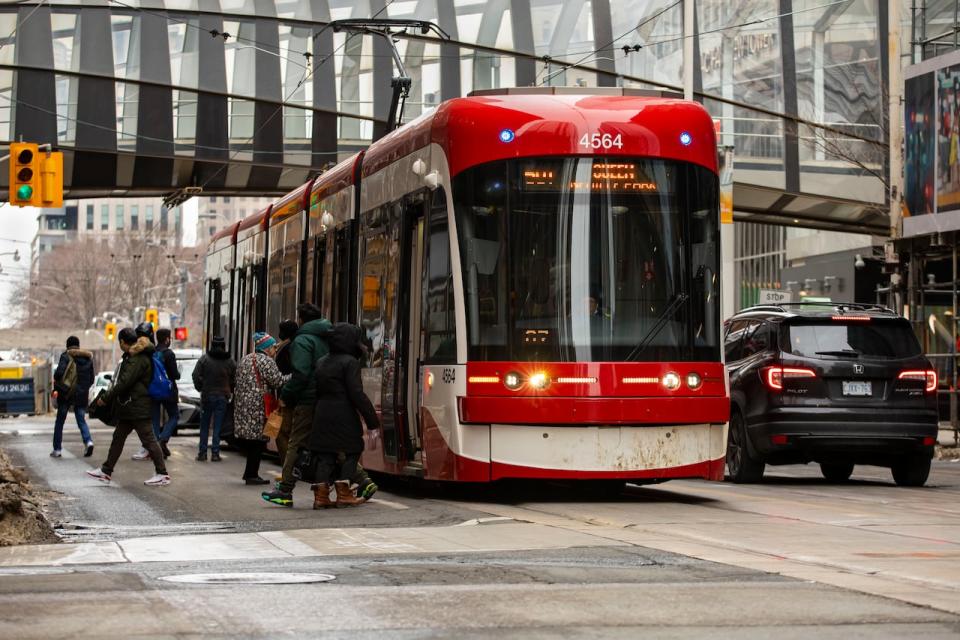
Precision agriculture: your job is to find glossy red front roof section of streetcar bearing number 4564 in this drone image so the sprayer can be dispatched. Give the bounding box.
[363,93,717,176]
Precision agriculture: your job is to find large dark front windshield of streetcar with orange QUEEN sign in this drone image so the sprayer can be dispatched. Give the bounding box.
[453,157,720,362]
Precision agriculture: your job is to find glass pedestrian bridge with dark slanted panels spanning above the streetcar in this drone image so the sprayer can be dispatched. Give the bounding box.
[0,0,889,231]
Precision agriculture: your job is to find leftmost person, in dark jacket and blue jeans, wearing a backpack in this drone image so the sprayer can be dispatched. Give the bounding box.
[50,336,93,458]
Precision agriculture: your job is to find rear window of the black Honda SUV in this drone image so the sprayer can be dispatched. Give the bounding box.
[784,320,921,359]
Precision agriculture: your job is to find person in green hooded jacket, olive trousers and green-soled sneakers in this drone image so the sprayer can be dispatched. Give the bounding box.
[261,303,333,507]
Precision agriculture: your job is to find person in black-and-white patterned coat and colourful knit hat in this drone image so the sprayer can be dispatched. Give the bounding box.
[233,333,286,484]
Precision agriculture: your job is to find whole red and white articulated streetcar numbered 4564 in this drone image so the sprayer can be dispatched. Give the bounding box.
[205,89,730,482]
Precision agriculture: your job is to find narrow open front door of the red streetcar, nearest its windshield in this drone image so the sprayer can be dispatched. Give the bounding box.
[406,208,424,462]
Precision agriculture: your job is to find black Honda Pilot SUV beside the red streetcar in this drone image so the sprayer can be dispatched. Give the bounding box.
[724,303,937,487]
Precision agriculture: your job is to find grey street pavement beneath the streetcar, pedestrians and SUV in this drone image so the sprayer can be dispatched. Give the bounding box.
[0,412,960,640]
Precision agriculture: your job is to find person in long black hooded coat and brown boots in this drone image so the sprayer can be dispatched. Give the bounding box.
[303,323,380,509]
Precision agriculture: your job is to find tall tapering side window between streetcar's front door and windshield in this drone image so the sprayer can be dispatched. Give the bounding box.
[421,188,457,364]
